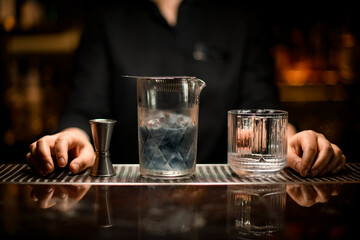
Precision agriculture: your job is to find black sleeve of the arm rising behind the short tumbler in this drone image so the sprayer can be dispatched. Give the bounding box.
[240,10,280,108]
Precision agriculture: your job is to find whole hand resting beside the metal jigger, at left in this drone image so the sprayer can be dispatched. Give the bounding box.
[26,128,96,175]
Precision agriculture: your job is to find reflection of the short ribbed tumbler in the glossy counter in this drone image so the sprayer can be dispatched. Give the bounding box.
[226,184,286,239]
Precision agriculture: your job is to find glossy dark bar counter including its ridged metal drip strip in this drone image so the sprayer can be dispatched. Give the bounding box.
[0,164,360,240]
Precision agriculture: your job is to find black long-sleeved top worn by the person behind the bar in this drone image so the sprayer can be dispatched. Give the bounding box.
[58,0,280,163]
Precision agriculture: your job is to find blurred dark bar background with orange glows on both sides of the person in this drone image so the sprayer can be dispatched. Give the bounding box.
[0,0,360,162]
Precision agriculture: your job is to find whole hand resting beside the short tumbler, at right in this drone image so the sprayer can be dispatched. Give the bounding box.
[287,130,346,177]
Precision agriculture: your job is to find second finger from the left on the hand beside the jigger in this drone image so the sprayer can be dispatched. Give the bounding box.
[36,138,54,174]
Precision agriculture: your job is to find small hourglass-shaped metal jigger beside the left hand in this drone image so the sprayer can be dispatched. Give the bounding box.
[89,119,116,177]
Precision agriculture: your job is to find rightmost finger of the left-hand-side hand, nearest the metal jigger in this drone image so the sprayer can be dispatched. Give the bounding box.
[69,146,95,174]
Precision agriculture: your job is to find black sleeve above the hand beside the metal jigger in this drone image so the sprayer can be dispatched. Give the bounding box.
[58,15,110,136]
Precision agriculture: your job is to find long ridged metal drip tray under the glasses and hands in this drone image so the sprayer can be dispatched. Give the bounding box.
[0,164,360,186]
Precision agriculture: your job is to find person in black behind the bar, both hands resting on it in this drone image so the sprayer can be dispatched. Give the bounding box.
[26,0,345,176]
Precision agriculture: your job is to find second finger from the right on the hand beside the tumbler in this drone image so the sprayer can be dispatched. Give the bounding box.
[310,137,334,177]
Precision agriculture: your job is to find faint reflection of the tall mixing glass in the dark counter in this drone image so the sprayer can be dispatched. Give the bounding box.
[139,186,198,239]
